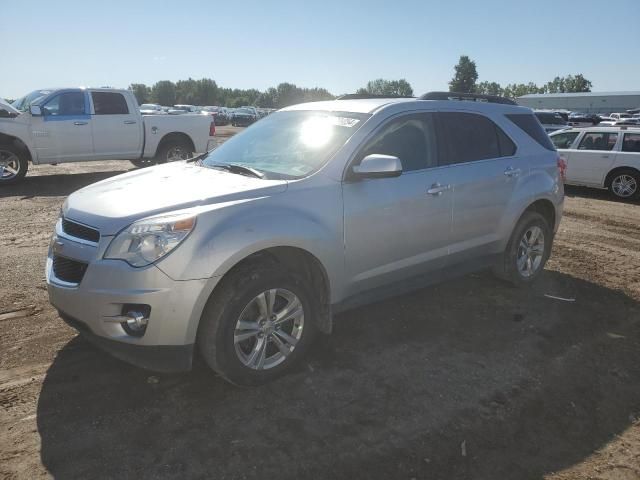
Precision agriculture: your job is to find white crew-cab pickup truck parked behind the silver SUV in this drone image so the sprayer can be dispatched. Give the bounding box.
[0,88,215,186]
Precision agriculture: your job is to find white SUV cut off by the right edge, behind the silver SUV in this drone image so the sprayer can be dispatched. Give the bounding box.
[551,126,640,200]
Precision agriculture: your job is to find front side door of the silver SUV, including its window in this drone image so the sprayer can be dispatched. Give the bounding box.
[343,113,452,294]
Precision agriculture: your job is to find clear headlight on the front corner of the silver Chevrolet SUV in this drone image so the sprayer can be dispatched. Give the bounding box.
[104,215,196,267]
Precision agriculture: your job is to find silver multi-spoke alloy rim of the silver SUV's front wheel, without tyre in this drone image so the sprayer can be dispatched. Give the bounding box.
[233,288,304,370]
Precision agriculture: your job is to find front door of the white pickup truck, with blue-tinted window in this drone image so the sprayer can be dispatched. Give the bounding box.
[31,90,94,163]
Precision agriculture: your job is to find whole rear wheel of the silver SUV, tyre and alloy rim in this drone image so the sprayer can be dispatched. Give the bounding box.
[494,212,553,287]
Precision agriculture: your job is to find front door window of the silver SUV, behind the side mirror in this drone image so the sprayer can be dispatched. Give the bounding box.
[356,113,437,172]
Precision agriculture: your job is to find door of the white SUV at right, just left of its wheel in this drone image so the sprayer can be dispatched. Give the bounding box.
[567,130,619,186]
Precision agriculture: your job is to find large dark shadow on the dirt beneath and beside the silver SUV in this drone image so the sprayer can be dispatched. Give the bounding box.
[37,271,640,480]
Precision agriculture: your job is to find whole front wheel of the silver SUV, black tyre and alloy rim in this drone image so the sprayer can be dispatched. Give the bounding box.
[198,265,317,386]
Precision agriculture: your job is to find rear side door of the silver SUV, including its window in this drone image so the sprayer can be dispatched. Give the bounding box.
[437,111,528,263]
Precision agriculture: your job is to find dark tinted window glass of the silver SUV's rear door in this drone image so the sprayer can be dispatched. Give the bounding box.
[437,112,516,165]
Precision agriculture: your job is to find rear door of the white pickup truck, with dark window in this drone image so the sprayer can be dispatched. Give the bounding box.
[91,91,143,160]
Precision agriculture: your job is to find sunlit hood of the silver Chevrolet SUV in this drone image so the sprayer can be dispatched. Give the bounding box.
[63,162,287,235]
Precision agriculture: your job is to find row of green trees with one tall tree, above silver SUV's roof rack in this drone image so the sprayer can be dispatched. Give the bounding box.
[449,55,593,98]
